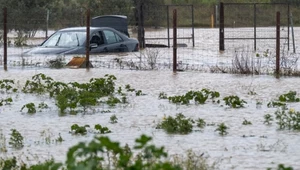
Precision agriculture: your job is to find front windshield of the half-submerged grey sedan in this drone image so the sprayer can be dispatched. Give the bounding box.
[42,31,86,47]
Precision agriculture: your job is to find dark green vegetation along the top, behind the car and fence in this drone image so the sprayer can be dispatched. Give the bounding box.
[0,0,300,37]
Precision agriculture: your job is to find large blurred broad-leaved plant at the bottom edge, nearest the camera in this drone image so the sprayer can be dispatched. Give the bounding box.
[66,135,180,170]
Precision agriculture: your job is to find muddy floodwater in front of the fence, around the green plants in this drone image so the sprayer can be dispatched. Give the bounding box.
[0,69,300,169]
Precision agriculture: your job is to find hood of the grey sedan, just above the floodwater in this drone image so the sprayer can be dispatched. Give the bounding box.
[25,46,85,55]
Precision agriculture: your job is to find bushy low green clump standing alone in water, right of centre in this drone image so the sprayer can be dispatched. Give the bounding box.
[156,113,194,134]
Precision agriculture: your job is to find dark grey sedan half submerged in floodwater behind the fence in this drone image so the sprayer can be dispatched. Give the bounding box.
[25,27,139,55]
